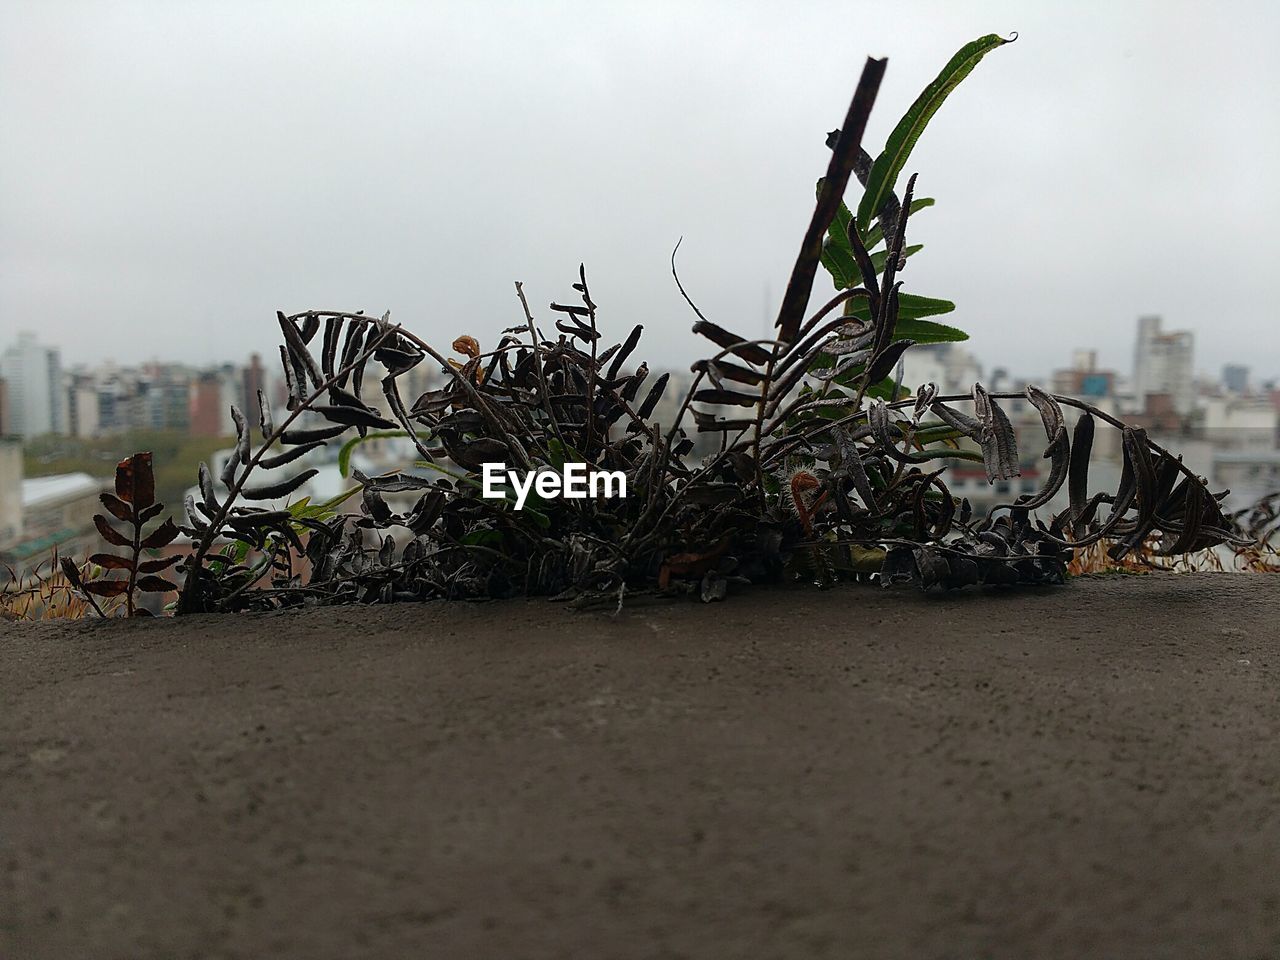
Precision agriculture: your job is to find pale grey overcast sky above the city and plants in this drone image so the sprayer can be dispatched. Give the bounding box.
[0,0,1280,378]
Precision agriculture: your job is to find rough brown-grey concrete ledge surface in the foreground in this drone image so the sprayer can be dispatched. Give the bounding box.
[0,575,1280,960]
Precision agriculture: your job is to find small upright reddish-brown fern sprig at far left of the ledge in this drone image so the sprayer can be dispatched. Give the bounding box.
[61,453,180,617]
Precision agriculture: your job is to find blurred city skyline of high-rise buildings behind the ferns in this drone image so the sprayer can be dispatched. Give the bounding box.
[0,315,1280,445]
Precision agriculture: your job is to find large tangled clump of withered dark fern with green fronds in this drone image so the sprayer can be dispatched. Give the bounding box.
[147,36,1244,612]
